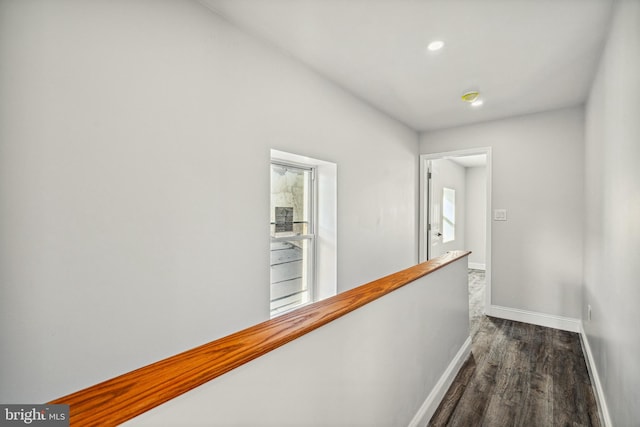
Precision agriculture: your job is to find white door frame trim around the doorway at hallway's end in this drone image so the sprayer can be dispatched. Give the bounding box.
[418,147,492,313]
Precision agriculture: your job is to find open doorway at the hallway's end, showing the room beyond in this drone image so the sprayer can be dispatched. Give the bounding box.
[419,147,491,320]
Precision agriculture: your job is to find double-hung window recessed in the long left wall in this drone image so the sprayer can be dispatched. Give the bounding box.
[270,161,316,316]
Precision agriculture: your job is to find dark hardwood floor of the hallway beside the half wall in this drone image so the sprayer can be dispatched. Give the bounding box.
[428,272,601,427]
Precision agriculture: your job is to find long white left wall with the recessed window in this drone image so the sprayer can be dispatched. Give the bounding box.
[0,0,417,403]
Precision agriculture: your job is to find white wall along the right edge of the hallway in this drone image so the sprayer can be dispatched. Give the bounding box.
[583,1,640,426]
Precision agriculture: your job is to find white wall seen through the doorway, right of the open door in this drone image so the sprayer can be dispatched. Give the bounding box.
[465,166,487,269]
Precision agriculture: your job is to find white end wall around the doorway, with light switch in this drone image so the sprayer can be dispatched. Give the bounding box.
[420,108,584,318]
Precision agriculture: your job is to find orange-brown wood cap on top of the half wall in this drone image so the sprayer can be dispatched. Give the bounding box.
[49,251,470,426]
